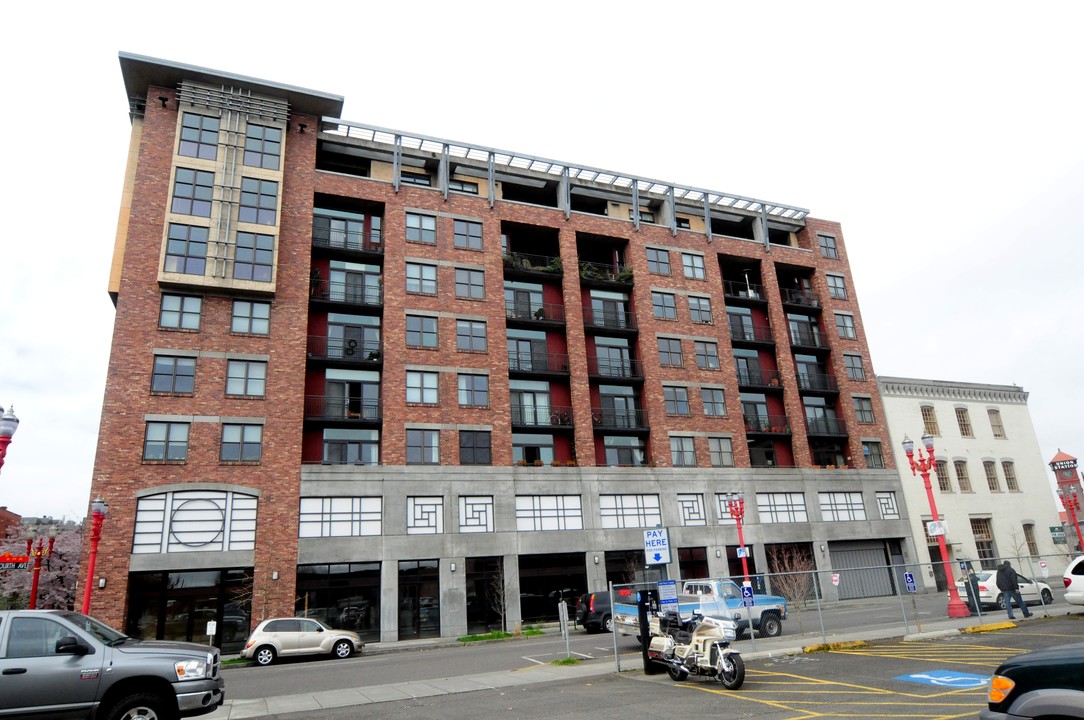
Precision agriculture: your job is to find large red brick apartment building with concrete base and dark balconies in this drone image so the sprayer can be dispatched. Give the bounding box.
[84,53,915,650]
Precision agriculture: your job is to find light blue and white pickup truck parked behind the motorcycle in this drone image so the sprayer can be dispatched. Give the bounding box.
[614,579,787,638]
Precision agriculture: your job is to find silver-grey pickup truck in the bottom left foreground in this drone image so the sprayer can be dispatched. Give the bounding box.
[0,610,224,720]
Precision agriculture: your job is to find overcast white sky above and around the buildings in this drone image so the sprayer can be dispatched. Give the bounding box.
[0,0,1084,518]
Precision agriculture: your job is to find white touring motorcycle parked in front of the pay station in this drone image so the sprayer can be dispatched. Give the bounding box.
[647,612,745,690]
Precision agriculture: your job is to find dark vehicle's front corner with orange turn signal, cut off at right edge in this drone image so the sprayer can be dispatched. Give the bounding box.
[979,643,1084,720]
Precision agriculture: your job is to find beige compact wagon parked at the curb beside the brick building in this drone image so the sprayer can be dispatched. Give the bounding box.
[241,617,364,665]
